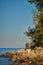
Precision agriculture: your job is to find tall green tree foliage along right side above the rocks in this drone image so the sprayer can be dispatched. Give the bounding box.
[25,0,43,47]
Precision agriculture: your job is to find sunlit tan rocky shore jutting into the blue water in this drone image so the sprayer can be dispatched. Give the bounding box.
[0,47,43,65]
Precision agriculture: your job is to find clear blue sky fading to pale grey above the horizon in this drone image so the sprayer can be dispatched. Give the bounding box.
[0,0,35,48]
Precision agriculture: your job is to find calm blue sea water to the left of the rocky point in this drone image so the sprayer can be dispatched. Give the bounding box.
[0,48,21,65]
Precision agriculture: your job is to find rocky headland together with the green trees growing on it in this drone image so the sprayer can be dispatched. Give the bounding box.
[0,0,43,65]
